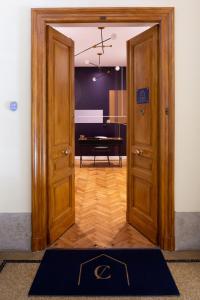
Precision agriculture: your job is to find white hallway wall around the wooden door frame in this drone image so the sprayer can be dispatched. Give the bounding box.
[0,0,200,212]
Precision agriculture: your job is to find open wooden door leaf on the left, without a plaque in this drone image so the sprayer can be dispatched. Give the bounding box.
[47,26,75,243]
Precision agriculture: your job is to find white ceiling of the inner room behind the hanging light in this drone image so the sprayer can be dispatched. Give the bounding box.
[54,25,149,67]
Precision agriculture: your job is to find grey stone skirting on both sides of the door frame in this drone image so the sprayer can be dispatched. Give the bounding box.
[0,212,200,251]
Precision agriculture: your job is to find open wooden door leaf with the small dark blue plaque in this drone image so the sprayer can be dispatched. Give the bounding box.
[127,26,159,244]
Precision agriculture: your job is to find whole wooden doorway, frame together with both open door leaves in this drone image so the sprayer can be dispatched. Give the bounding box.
[32,8,174,250]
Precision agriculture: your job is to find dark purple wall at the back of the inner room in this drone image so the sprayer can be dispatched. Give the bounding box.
[75,67,126,155]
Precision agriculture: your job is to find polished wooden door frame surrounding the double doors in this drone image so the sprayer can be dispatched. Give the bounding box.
[32,7,175,251]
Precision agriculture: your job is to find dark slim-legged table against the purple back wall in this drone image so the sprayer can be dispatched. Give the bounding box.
[78,137,123,167]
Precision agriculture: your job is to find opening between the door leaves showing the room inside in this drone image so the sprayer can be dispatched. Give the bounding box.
[49,23,157,248]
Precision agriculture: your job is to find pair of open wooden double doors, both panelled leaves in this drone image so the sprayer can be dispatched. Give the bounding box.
[47,26,159,244]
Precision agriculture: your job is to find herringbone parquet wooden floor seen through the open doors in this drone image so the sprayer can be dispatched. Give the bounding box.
[52,158,154,248]
